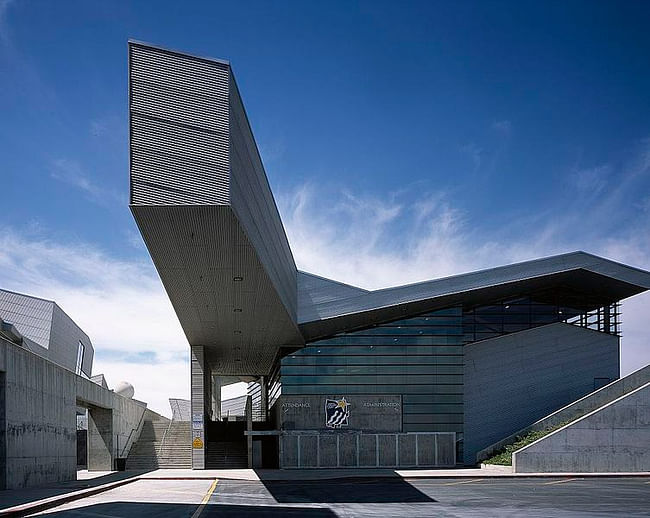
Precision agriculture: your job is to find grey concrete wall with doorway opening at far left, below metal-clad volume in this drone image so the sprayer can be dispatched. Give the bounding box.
[0,339,146,489]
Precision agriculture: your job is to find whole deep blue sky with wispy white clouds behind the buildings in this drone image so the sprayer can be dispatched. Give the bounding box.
[0,0,650,412]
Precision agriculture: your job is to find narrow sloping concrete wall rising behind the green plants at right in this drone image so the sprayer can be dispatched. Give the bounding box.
[476,365,650,462]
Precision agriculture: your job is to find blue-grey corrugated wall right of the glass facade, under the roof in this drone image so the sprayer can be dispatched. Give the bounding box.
[464,323,619,464]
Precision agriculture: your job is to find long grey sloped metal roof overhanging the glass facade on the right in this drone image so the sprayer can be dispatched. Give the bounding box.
[298,252,650,340]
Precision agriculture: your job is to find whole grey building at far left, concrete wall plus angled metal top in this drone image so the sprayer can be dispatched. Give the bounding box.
[0,290,147,490]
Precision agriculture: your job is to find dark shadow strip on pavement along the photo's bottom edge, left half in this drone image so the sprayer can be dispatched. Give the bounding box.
[39,502,336,518]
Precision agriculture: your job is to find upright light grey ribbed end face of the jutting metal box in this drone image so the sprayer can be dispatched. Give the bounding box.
[129,43,230,205]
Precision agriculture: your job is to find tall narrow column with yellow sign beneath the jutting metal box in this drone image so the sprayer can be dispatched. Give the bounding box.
[190,345,205,469]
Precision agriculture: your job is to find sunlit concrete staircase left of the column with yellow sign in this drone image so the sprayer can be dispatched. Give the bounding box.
[126,412,192,470]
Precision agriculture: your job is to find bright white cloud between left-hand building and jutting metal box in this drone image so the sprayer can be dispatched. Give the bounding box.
[0,230,189,414]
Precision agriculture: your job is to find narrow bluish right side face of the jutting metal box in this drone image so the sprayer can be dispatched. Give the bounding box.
[230,71,297,319]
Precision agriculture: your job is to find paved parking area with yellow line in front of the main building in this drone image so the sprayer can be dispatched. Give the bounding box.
[25,477,650,518]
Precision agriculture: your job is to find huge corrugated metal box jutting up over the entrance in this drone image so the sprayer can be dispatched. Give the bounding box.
[129,42,304,375]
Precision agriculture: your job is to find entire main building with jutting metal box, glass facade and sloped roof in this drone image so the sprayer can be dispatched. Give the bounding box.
[129,41,650,469]
